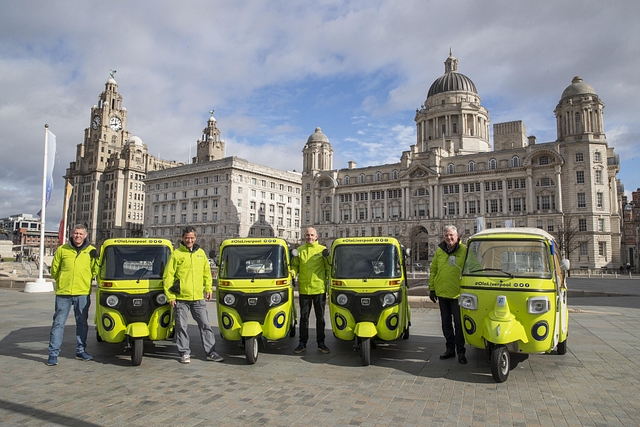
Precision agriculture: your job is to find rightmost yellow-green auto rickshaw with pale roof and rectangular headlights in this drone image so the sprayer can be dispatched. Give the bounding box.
[459,228,569,382]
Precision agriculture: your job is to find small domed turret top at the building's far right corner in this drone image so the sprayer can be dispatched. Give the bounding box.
[553,76,604,142]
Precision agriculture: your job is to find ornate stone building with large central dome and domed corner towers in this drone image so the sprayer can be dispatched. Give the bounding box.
[302,54,622,269]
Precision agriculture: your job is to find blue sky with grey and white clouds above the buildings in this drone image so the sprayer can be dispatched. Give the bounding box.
[0,0,640,230]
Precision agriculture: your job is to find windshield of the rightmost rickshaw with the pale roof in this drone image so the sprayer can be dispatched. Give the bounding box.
[462,239,551,279]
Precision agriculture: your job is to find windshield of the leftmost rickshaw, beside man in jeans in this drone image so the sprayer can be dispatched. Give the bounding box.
[100,245,171,280]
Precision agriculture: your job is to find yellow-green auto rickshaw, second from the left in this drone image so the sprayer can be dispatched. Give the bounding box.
[216,237,296,364]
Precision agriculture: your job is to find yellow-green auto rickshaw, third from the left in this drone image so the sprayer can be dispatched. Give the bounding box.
[329,237,411,366]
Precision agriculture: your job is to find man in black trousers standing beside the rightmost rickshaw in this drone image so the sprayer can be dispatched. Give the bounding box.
[429,225,467,364]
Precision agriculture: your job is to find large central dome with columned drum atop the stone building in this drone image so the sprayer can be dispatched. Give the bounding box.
[414,51,490,154]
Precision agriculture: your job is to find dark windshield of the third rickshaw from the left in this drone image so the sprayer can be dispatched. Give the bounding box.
[332,245,402,279]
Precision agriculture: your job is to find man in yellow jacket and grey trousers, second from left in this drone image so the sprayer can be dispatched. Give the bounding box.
[162,227,224,363]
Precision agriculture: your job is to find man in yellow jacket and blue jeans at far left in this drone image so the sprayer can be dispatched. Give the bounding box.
[47,224,98,366]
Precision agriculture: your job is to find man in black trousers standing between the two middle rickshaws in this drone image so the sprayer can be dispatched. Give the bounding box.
[291,228,329,353]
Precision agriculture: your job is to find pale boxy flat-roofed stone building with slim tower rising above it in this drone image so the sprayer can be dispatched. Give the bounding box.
[144,112,302,252]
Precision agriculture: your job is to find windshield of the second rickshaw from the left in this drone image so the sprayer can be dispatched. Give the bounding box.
[218,245,289,279]
